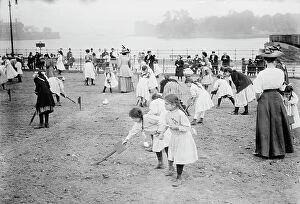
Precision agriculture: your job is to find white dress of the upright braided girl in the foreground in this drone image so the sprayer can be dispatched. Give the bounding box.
[165,109,198,164]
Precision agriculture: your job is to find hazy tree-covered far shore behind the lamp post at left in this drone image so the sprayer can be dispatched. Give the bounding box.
[0,21,60,41]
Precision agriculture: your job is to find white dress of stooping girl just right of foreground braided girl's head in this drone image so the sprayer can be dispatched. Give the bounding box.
[190,83,214,113]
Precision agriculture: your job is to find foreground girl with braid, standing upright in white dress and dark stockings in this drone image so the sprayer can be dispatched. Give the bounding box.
[160,94,198,187]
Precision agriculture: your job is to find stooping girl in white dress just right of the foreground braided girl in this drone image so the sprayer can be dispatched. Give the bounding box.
[185,78,214,125]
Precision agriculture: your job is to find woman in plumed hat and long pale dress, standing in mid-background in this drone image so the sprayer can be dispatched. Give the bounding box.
[118,48,133,93]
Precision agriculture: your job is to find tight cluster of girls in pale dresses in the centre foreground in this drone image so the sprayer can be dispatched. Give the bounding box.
[123,93,198,187]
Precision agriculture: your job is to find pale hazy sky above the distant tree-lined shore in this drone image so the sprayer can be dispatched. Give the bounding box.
[0,0,300,35]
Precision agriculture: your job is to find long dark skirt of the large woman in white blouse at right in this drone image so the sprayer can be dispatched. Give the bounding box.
[255,90,294,157]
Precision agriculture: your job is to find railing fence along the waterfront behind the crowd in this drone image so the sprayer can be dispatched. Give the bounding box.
[0,48,300,77]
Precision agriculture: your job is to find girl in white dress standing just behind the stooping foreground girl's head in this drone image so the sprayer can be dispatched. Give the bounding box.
[136,66,150,107]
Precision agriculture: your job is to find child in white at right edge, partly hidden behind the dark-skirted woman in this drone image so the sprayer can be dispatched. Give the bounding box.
[283,85,300,129]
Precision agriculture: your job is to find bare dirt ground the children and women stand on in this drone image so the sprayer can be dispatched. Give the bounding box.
[0,72,300,204]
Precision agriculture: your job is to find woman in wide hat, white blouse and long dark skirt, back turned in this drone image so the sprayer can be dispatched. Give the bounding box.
[254,48,294,158]
